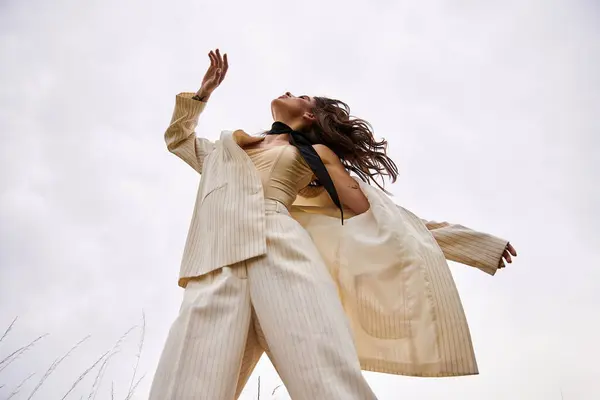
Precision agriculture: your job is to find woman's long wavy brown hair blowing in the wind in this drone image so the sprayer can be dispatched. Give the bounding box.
[305,97,398,190]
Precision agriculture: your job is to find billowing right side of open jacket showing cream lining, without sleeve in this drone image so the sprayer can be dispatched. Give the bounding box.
[293,180,486,377]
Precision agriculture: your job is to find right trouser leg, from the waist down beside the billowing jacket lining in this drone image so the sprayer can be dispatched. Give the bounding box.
[248,213,376,400]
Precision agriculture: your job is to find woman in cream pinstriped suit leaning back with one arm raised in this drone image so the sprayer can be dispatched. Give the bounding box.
[150,49,510,400]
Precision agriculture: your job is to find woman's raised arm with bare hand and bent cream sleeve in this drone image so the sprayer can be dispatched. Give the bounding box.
[165,49,229,174]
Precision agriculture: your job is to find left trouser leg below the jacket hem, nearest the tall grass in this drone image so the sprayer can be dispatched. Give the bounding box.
[150,263,250,400]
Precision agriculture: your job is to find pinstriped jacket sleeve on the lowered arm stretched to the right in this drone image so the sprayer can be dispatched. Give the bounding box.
[422,220,508,275]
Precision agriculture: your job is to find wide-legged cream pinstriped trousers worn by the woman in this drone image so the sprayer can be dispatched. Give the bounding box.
[150,200,376,400]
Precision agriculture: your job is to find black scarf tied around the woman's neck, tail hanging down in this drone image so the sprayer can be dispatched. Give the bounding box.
[266,121,344,225]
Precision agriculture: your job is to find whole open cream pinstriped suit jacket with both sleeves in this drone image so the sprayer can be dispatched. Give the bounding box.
[165,93,508,377]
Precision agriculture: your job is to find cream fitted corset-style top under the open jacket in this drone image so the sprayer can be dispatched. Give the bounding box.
[244,144,314,208]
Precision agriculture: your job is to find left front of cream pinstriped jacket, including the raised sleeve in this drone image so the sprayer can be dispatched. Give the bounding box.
[165,93,266,287]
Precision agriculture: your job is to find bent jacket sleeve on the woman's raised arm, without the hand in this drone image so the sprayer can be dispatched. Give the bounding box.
[165,92,215,174]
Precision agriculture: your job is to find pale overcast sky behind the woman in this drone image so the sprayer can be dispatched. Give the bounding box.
[0,0,600,400]
